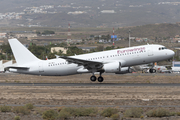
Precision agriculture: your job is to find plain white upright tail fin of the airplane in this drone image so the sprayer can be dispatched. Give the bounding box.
[8,39,39,65]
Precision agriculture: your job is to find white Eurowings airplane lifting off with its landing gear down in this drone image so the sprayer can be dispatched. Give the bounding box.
[6,39,174,82]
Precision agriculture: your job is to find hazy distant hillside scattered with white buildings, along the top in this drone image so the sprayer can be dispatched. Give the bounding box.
[0,0,180,28]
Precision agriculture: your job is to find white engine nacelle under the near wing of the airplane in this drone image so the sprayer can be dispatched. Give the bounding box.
[103,62,121,73]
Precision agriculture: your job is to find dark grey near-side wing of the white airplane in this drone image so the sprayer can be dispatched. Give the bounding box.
[60,56,103,70]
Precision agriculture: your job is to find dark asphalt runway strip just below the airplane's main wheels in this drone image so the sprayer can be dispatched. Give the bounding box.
[0,83,180,87]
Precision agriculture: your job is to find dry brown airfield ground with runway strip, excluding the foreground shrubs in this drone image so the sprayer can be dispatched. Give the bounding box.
[0,73,180,120]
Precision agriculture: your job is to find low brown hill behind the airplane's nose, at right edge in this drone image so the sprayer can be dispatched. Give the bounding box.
[115,23,180,39]
